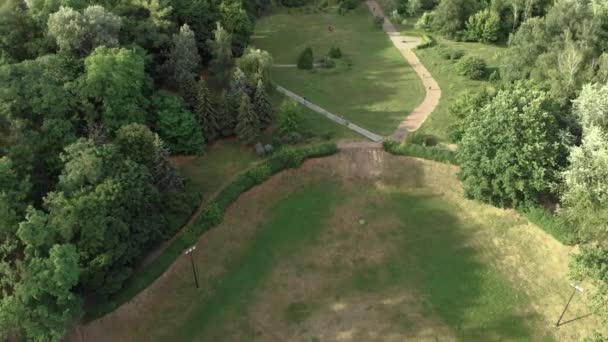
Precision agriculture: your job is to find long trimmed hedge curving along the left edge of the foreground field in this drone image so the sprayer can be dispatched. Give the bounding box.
[85,143,338,322]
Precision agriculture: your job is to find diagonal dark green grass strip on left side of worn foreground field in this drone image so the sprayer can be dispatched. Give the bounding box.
[174,182,340,341]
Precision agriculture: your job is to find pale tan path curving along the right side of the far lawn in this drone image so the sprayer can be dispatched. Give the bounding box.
[365,0,441,141]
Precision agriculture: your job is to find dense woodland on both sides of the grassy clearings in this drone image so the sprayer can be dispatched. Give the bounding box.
[0,0,608,341]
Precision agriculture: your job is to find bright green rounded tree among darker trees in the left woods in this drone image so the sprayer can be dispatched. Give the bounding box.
[80,46,147,133]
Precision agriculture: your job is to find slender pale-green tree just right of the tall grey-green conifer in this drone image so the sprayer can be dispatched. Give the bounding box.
[209,23,234,84]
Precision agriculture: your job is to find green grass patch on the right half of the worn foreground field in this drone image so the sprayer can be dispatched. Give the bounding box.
[352,193,546,340]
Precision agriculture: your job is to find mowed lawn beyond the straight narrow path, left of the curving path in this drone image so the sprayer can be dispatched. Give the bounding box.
[253,5,424,135]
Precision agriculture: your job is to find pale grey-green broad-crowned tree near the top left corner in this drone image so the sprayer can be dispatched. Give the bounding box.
[48,5,122,55]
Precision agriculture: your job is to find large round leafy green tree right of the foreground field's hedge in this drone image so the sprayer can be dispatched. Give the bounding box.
[458,82,565,207]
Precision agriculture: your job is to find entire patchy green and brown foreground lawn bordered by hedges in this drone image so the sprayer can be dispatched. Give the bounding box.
[84,151,601,341]
